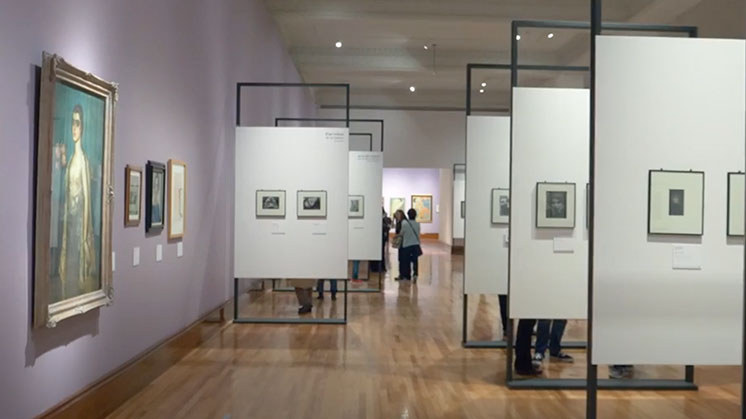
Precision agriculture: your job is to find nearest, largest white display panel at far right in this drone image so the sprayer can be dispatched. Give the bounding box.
[592,36,746,365]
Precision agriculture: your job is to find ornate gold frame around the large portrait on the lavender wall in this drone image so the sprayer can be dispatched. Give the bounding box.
[33,52,118,328]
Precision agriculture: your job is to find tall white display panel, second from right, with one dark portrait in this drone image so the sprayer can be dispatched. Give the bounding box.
[510,88,590,319]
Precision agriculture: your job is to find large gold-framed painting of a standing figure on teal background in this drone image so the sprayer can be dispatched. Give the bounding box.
[33,53,117,328]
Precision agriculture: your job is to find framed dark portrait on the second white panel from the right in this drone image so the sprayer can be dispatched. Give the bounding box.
[536,182,575,228]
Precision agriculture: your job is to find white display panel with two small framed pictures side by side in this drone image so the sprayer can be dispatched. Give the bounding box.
[233,127,349,279]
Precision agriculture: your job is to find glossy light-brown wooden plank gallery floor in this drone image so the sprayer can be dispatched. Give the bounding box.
[110,242,741,419]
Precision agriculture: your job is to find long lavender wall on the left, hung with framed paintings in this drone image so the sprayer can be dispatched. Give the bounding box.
[0,0,314,418]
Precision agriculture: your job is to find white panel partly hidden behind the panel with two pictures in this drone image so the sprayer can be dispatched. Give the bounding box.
[348,151,383,260]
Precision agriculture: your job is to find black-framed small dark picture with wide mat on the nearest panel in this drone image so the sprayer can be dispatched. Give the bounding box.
[648,170,705,236]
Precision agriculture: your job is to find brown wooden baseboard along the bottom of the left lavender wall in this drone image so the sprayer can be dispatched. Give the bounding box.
[38,299,233,419]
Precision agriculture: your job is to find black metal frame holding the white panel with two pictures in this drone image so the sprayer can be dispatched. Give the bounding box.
[233,82,350,324]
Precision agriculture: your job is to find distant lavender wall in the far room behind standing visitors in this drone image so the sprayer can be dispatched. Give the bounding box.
[383,168,442,238]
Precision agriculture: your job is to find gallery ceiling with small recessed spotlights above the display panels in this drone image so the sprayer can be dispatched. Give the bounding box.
[264,0,746,109]
